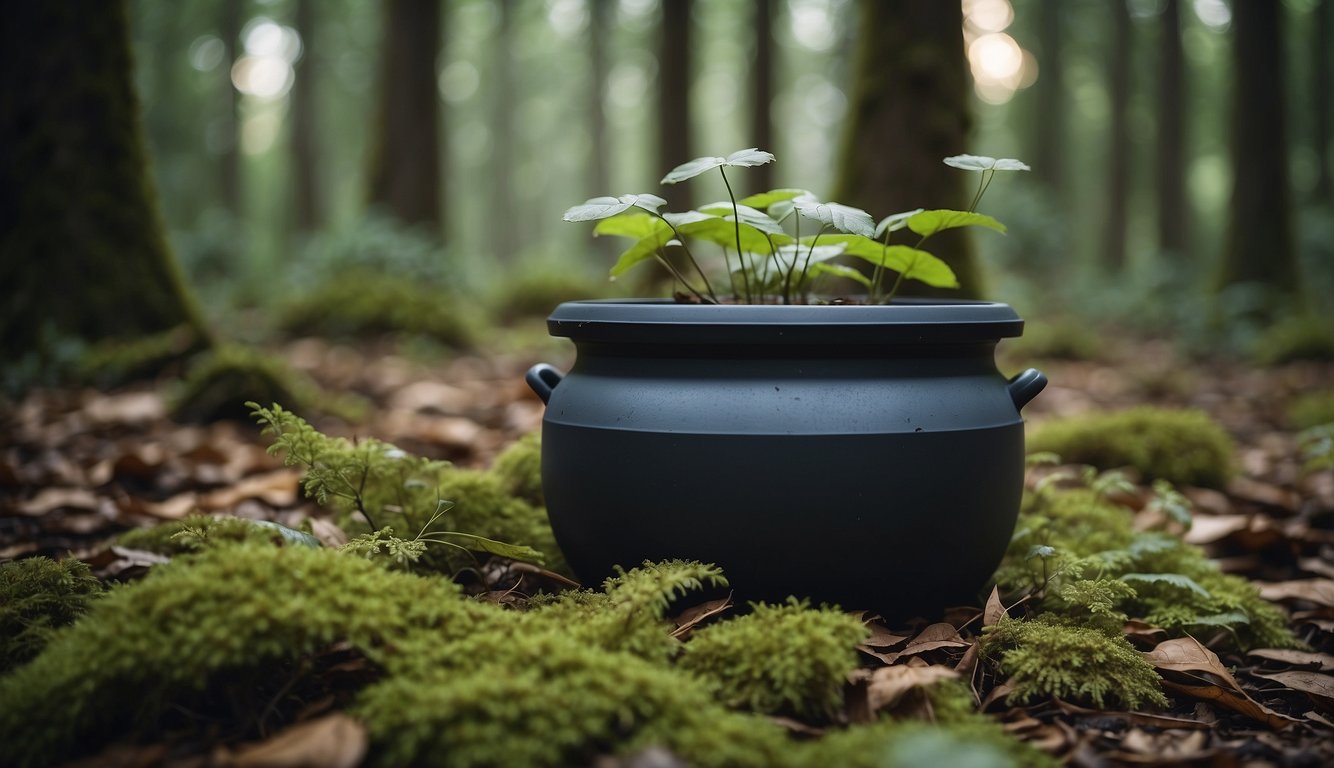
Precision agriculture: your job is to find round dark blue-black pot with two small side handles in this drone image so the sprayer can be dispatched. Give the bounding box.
[527,300,1047,616]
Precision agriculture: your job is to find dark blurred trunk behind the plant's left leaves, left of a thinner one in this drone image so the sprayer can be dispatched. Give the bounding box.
[658,0,694,211]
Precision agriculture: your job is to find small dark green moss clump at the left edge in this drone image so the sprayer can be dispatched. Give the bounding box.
[0,557,101,675]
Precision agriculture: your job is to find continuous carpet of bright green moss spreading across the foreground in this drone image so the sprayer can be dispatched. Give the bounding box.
[0,540,1050,767]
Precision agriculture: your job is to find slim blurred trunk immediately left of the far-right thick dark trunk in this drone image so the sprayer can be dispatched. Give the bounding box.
[1155,0,1190,260]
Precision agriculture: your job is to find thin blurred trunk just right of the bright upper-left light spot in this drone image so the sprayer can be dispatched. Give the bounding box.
[292,0,323,232]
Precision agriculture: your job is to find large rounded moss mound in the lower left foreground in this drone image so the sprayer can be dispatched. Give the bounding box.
[0,544,486,765]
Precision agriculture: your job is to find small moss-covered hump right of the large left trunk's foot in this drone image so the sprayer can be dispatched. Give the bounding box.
[169,344,366,421]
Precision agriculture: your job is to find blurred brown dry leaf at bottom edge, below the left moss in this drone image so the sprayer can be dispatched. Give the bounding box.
[223,713,368,768]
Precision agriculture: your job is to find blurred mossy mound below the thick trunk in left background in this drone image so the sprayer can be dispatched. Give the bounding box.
[279,268,474,347]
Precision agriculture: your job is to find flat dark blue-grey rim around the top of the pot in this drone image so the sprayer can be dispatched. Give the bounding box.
[547,299,1023,344]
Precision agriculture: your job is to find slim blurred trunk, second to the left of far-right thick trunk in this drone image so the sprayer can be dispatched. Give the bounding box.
[1102,0,1131,273]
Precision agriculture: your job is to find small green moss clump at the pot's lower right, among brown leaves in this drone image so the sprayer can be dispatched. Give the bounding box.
[982,616,1167,709]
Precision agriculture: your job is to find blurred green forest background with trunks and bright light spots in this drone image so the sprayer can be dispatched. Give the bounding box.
[4,0,1334,389]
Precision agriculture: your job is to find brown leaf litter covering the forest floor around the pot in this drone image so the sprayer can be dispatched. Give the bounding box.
[0,332,1334,767]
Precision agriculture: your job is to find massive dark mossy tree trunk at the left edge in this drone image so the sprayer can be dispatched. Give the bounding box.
[0,0,207,364]
